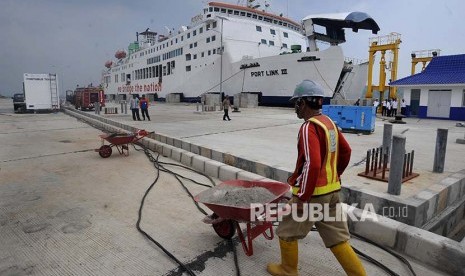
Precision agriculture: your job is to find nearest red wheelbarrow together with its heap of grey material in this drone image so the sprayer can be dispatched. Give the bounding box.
[194,180,289,256]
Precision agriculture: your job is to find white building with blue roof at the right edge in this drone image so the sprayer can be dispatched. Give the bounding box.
[389,54,465,121]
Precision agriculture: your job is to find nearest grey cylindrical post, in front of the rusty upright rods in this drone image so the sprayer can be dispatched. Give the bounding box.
[388,135,405,195]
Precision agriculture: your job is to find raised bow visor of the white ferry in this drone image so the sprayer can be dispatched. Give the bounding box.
[302,12,380,51]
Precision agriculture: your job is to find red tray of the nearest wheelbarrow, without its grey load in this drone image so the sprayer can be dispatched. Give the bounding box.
[194,180,289,222]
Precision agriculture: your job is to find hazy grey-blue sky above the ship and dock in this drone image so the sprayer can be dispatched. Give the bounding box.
[0,0,465,96]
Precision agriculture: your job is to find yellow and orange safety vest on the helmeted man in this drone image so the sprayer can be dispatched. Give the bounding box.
[292,115,341,196]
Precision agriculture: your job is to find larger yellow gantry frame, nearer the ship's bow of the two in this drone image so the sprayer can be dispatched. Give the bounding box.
[366,33,402,100]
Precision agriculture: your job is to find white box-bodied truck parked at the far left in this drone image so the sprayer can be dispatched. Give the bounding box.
[23,73,60,111]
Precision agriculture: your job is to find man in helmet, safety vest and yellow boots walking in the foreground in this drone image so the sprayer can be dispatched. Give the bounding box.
[267,80,366,275]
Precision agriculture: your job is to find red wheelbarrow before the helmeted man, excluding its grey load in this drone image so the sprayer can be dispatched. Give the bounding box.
[194,180,289,256]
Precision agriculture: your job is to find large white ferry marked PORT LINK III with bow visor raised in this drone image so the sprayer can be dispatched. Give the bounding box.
[102,1,379,105]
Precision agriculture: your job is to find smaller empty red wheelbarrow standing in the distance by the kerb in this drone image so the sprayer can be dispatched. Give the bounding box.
[95,129,153,158]
